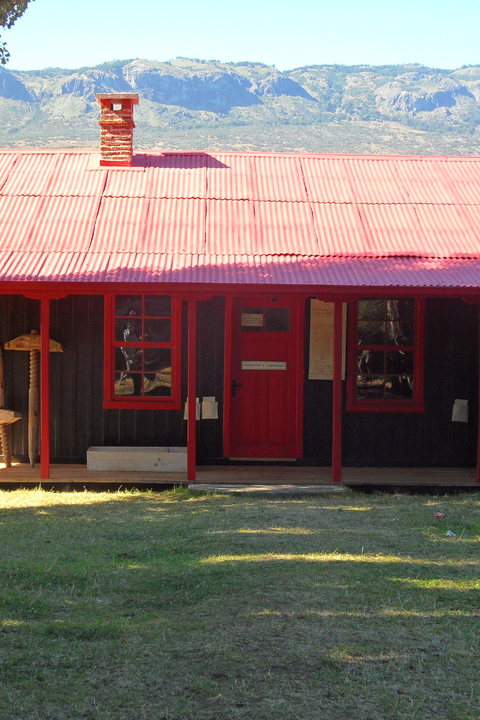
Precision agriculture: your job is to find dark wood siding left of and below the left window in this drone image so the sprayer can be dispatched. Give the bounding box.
[51,296,186,462]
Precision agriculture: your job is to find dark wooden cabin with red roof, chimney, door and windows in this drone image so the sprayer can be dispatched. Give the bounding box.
[0,94,480,482]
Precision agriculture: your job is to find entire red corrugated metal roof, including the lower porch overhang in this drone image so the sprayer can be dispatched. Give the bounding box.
[0,150,480,287]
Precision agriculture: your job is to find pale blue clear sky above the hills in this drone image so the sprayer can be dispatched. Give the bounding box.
[1,0,480,70]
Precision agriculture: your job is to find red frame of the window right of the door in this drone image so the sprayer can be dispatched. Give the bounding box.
[347,295,425,413]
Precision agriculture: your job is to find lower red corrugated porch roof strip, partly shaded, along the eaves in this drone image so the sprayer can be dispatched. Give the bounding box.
[0,251,480,289]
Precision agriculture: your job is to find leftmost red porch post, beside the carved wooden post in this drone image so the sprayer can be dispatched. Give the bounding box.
[40,297,50,480]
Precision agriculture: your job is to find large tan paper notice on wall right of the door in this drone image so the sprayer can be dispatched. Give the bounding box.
[308,300,347,380]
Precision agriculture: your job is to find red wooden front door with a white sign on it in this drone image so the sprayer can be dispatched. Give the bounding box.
[229,296,303,459]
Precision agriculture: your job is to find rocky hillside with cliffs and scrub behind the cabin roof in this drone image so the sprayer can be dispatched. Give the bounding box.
[0,58,480,155]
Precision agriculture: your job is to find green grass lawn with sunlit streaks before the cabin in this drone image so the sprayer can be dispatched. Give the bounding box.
[0,490,480,720]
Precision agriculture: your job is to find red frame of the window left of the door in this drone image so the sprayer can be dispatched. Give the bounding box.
[103,292,182,410]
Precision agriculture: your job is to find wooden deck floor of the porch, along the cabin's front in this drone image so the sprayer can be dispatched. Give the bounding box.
[0,463,480,489]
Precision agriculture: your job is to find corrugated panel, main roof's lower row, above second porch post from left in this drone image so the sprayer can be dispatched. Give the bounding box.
[146,198,206,253]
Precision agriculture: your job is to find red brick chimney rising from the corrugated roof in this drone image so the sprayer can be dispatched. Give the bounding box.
[95,93,138,167]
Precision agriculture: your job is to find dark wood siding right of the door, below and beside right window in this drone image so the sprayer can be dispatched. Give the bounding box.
[305,299,478,467]
